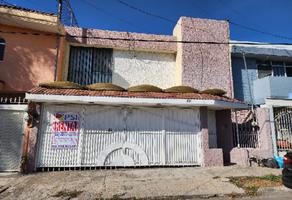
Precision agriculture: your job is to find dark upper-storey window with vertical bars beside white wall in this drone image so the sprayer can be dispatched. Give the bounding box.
[68,46,113,85]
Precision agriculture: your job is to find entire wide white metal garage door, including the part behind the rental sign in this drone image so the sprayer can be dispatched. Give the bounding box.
[37,106,201,167]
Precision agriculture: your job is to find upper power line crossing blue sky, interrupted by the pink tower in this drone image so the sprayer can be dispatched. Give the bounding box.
[116,0,292,40]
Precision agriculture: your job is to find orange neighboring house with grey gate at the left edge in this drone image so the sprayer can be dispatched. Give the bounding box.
[0,5,63,171]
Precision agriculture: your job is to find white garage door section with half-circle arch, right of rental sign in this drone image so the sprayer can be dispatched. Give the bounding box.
[82,106,200,166]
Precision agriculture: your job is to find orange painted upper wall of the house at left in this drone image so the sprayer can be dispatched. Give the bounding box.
[0,24,57,92]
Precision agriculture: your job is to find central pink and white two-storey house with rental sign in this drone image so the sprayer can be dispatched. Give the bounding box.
[26,17,246,170]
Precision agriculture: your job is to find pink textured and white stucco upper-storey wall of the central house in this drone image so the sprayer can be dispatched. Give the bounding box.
[63,17,233,92]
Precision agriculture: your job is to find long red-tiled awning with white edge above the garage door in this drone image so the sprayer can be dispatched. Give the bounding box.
[26,87,248,110]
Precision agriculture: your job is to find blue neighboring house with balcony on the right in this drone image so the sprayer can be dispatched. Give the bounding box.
[231,41,292,165]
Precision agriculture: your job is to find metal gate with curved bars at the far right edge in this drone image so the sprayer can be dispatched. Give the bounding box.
[274,108,292,151]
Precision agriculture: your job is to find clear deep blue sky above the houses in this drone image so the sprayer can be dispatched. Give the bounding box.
[0,0,292,43]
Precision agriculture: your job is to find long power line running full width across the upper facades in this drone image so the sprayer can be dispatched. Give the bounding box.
[0,30,292,46]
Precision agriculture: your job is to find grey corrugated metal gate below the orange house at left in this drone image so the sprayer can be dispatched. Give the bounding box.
[0,110,23,171]
